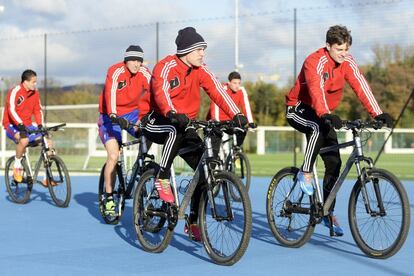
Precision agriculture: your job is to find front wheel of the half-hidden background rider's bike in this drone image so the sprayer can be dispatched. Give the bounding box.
[226,152,251,200]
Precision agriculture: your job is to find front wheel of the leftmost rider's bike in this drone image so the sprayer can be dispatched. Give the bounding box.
[47,156,72,207]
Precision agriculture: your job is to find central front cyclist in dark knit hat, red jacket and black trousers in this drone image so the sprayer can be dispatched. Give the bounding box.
[143,27,247,240]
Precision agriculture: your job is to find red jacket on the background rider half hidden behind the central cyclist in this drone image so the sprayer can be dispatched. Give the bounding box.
[207,83,253,123]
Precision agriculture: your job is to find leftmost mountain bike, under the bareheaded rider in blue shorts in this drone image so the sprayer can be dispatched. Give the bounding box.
[4,124,71,207]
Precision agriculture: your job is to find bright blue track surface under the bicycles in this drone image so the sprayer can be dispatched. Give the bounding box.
[0,176,414,276]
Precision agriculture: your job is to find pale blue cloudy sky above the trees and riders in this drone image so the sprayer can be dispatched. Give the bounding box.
[0,0,414,85]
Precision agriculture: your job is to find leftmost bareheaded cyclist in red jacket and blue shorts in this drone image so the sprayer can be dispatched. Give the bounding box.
[3,69,53,187]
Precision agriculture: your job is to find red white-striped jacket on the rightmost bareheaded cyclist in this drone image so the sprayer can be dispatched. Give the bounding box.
[286,48,382,117]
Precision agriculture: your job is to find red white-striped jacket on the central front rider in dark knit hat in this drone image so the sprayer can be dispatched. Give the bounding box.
[151,55,240,119]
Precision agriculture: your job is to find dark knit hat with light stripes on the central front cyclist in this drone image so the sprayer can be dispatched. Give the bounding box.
[175,27,207,56]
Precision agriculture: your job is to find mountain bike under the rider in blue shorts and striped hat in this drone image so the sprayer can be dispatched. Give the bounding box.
[98,124,158,224]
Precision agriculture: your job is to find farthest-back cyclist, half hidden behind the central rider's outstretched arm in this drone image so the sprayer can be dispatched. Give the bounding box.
[207,71,256,154]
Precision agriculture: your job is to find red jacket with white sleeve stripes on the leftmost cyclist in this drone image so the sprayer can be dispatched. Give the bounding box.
[3,84,44,128]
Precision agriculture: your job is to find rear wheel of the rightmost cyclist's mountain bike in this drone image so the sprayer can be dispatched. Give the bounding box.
[266,167,315,247]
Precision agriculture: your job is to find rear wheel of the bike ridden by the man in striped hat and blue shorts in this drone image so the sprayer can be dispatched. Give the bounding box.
[98,164,125,224]
